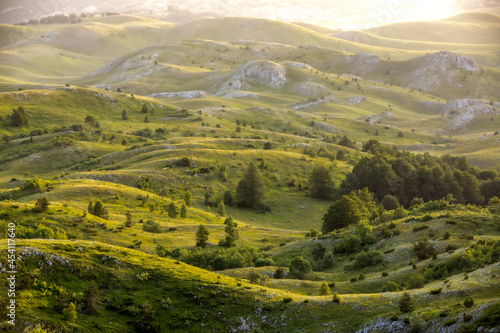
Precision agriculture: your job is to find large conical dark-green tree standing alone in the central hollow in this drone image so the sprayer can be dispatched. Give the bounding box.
[236,162,264,208]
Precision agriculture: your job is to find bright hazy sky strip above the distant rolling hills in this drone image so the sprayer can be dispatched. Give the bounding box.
[0,0,488,29]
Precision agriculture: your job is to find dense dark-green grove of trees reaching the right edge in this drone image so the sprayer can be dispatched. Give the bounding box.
[338,140,500,207]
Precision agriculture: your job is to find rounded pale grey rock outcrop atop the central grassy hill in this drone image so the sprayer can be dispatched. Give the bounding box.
[215,60,287,96]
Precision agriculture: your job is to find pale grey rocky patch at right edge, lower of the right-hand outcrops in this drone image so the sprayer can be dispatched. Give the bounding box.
[441,99,500,130]
